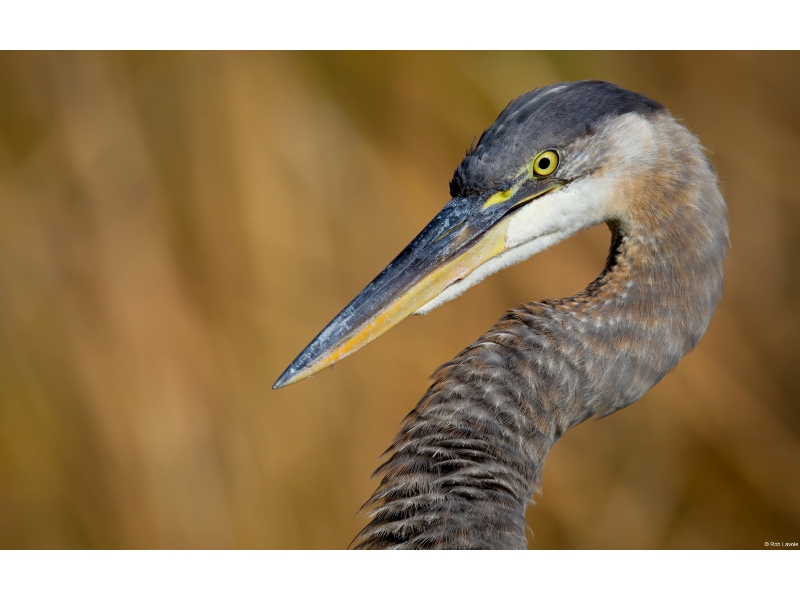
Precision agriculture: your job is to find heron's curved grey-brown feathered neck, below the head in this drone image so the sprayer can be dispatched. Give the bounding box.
[354,135,728,548]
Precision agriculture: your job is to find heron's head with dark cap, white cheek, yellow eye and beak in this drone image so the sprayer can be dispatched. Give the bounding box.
[274,81,666,388]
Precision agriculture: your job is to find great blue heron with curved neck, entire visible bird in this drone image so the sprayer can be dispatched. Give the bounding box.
[275,81,728,548]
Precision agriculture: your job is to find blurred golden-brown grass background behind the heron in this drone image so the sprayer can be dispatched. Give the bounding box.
[0,52,800,548]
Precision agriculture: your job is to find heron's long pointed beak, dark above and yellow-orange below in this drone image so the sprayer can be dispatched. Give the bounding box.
[272,181,563,389]
